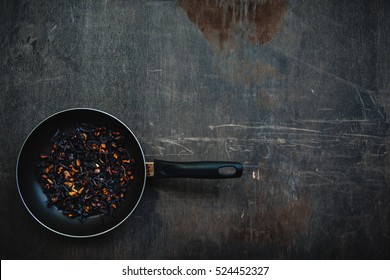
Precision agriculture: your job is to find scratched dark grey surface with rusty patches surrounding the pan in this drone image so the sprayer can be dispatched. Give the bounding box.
[0,0,390,259]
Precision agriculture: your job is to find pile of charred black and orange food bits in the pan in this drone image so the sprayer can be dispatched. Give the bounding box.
[36,124,135,222]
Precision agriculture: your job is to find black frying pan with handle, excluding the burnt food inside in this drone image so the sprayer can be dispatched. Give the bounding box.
[16,108,243,238]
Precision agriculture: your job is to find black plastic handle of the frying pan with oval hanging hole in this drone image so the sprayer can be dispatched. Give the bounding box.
[154,159,243,179]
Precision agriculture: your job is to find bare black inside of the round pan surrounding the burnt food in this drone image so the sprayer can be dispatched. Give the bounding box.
[17,109,145,237]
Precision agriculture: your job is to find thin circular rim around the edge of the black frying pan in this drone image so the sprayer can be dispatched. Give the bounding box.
[16,107,146,238]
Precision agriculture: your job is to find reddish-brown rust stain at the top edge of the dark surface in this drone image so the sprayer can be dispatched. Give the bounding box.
[179,0,287,48]
